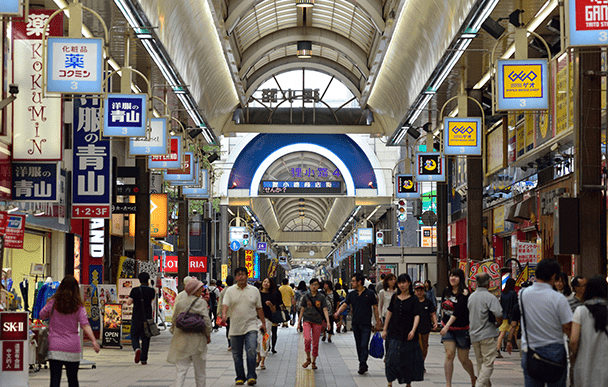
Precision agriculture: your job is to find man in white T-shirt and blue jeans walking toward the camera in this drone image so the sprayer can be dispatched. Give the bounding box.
[222,267,266,386]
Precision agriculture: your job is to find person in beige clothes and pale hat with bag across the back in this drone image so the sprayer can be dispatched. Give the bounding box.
[167,278,211,387]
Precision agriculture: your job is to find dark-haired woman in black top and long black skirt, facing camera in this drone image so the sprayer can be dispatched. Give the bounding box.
[382,274,424,387]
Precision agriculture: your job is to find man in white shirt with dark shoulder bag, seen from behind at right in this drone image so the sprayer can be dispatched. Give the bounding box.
[519,259,572,387]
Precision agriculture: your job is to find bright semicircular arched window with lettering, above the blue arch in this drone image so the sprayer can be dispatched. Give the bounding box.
[249,70,359,108]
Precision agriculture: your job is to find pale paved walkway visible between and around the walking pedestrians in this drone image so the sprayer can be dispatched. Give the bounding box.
[30,327,524,387]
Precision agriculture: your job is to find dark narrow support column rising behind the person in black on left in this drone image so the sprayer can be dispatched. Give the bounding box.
[135,156,150,262]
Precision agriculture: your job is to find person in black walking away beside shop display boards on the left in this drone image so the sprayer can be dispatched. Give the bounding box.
[127,272,156,365]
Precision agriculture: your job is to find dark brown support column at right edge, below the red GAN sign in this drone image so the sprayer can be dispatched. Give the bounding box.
[574,51,606,278]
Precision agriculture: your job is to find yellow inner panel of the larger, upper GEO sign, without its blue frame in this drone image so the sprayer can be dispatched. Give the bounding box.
[502,64,544,98]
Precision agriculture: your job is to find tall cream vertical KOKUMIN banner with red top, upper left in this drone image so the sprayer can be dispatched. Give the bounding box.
[11,9,63,161]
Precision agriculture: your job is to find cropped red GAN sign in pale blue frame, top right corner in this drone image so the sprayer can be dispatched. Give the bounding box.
[566,0,608,46]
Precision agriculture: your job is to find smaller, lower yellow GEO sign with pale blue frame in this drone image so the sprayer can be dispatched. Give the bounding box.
[443,117,483,155]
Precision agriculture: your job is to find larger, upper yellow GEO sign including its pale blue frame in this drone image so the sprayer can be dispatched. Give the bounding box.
[496,59,549,110]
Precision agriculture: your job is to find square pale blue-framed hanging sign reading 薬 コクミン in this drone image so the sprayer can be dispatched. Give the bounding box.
[46,38,104,94]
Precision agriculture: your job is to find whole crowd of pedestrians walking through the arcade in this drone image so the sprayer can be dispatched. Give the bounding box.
[40,259,608,387]
